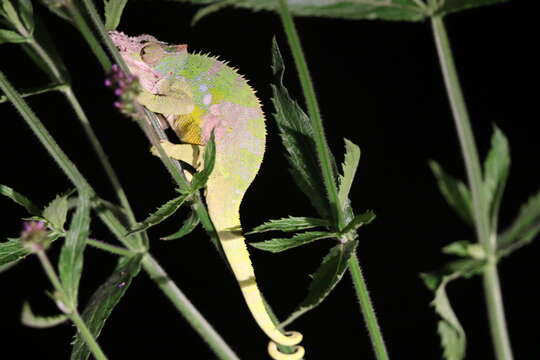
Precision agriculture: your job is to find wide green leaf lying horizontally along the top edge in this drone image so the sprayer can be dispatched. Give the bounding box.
[184,0,427,21]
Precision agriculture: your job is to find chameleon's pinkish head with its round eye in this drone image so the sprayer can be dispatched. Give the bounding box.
[109,31,187,90]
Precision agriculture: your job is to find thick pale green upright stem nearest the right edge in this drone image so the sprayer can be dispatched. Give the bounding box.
[431,16,513,360]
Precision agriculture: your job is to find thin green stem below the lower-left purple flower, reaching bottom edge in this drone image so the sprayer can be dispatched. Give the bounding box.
[36,249,107,360]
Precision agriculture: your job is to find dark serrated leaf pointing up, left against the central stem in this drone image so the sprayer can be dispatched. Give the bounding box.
[272,39,329,219]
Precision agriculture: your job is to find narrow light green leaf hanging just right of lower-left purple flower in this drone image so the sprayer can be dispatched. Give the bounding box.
[58,189,90,308]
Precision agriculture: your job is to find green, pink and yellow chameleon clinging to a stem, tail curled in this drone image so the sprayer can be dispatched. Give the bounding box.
[109,31,305,360]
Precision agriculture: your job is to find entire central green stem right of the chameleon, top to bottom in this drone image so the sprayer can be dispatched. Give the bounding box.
[279,0,389,360]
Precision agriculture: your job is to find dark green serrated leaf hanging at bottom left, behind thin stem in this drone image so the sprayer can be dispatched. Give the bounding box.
[70,254,142,360]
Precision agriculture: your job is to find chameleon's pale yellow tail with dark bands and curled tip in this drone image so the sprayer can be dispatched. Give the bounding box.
[218,226,305,360]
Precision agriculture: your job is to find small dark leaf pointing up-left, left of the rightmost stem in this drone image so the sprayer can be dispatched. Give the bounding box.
[429,161,473,225]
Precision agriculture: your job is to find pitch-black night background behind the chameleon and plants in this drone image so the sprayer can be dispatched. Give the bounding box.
[0,1,540,359]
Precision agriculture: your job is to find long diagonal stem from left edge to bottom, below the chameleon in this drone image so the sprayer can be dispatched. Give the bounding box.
[0,71,236,359]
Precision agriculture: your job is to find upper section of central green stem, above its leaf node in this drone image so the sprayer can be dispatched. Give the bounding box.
[279,0,345,229]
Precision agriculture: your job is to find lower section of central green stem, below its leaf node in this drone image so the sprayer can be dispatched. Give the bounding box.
[349,254,389,360]
